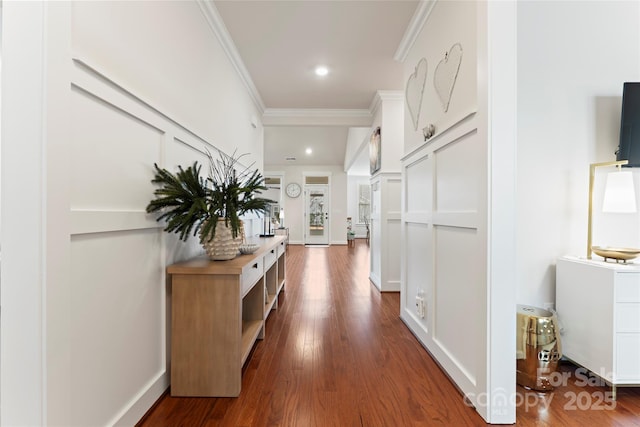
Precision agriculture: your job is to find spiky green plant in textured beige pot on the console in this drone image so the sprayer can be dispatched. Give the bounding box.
[147,150,275,260]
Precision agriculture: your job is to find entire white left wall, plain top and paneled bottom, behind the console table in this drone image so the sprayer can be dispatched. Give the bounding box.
[0,1,262,425]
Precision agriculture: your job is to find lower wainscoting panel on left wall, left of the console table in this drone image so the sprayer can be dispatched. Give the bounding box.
[69,229,166,425]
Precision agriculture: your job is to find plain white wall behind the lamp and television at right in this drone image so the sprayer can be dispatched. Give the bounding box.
[517,1,640,306]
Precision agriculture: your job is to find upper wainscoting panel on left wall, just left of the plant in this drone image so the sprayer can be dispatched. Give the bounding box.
[71,88,163,210]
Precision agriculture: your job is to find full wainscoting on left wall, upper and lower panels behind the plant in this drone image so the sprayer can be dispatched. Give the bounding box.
[67,55,239,426]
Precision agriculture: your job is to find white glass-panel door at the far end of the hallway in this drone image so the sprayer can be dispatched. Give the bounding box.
[304,185,329,245]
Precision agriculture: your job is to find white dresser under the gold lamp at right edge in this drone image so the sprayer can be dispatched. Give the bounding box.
[556,257,640,398]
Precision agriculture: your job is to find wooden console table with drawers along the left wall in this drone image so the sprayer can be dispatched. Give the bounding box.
[167,236,286,397]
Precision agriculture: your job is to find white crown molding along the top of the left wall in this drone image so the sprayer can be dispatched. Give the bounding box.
[197,0,266,114]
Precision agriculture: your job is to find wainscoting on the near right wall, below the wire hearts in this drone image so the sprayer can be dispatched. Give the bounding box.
[400,115,487,418]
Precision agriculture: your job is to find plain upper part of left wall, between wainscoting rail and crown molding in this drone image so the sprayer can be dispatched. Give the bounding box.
[72,1,263,169]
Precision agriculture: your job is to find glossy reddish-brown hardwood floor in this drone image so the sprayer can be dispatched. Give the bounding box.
[138,240,640,427]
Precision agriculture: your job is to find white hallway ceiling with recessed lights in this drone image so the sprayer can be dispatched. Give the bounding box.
[214,0,419,173]
